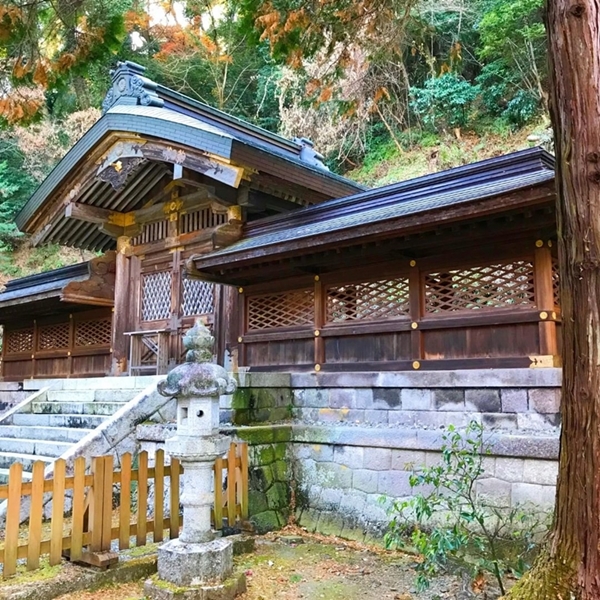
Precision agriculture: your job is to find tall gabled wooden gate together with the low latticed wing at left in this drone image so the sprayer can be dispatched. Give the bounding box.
[0,62,363,380]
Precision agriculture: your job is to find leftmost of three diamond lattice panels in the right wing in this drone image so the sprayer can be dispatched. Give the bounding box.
[248,290,315,331]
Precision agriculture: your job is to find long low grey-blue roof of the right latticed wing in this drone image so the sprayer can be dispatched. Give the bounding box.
[197,148,554,270]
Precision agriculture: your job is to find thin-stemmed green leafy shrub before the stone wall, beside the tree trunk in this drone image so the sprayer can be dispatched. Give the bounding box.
[382,421,548,595]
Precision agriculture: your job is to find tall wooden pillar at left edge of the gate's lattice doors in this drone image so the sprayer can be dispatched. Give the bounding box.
[111,236,134,375]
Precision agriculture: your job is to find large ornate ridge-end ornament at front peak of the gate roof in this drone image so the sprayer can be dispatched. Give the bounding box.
[102,60,164,114]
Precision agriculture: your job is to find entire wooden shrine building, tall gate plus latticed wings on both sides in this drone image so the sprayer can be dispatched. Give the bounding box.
[0,63,561,380]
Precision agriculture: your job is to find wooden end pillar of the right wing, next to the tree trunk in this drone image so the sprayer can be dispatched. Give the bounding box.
[533,240,558,356]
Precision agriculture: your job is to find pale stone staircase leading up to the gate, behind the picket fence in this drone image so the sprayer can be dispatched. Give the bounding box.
[0,377,163,483]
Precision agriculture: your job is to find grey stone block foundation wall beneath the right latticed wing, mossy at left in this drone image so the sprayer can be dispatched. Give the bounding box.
[231,369,560,539]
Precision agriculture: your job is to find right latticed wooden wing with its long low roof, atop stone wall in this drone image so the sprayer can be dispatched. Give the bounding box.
[191,148,561,371]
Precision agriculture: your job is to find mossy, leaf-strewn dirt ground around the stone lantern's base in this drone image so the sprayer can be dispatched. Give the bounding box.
[54,532,472,600]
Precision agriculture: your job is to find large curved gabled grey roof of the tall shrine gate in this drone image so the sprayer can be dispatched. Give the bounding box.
[16,62,364,244]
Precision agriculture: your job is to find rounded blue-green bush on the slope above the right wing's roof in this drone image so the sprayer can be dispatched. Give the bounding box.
[411,73,479,130]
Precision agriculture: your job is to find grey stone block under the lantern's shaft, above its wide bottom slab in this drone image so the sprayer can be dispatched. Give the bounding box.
[158,538,233,586]
